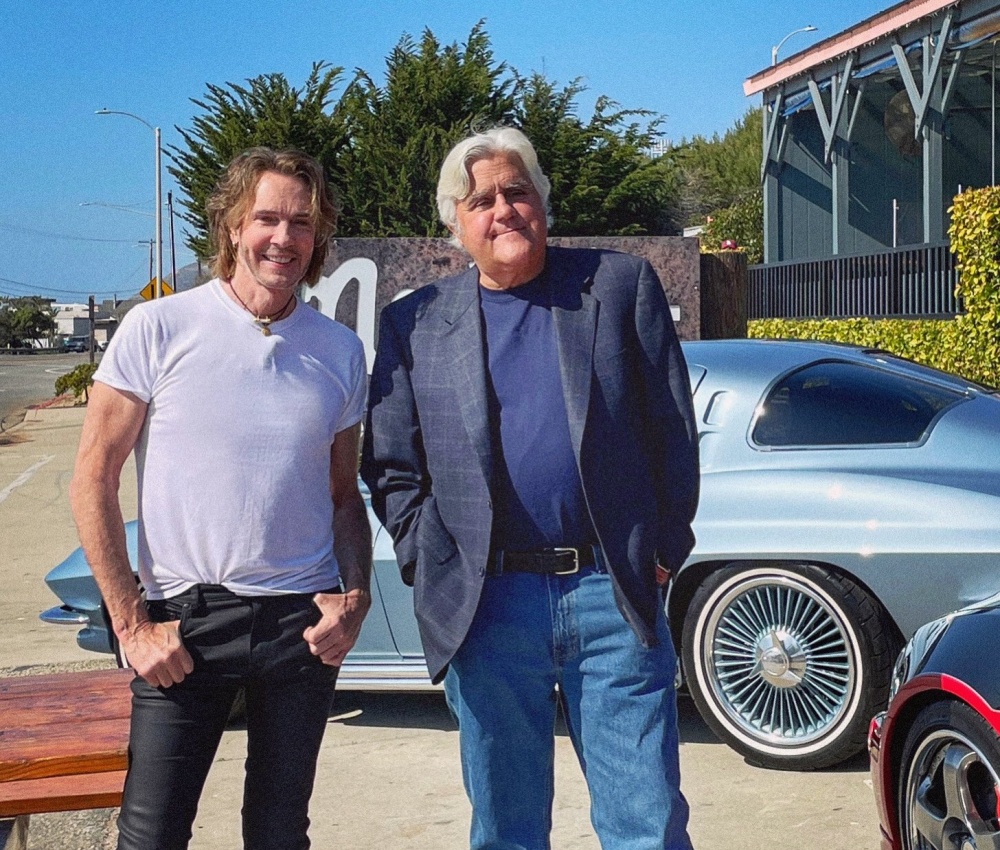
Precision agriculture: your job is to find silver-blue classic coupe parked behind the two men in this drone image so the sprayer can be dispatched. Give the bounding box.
[37,340,1000,769]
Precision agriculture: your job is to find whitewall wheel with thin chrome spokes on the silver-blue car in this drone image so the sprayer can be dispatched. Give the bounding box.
[682,564,898,770]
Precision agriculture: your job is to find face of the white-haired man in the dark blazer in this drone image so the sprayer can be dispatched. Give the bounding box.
[454,154,548,289]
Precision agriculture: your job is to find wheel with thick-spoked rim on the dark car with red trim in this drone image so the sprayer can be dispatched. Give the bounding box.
[899,701,1000,850]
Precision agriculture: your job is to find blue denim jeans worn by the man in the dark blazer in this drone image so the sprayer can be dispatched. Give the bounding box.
[445,569,691,850]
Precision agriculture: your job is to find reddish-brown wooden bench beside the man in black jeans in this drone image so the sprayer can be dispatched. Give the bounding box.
[0,670,134,850]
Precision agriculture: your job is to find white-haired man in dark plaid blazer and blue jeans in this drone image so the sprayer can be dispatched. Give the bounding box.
[362,127,698,850]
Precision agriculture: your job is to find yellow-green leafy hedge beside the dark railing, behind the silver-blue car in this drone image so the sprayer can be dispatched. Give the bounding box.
[747,187,1000,387]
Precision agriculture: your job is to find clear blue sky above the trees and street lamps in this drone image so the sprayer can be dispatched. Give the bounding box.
[0,0,890,301]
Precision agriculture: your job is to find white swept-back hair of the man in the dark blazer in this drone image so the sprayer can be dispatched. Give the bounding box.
[437,127,552,247]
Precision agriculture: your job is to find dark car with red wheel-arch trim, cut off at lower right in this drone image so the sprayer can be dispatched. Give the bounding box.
[868,595,1000,850]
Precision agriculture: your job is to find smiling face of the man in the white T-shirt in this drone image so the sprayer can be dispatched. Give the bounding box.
[229,171,316,291]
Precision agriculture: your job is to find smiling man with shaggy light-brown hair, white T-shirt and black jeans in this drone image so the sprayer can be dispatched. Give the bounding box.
[71,148,371,850]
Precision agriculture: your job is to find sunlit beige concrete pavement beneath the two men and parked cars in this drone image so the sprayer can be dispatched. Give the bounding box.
[0,407,878,850]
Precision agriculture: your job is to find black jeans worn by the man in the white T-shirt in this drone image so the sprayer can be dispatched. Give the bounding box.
[118,585,337,850]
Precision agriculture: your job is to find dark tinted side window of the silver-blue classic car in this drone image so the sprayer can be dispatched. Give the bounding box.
[750,361,965,447]
